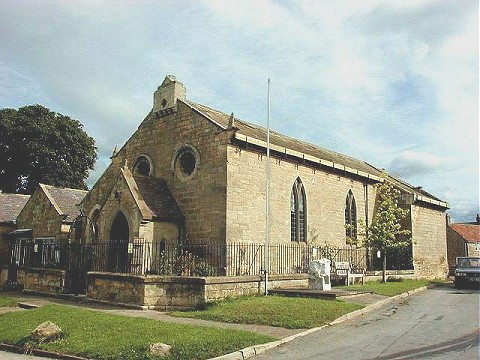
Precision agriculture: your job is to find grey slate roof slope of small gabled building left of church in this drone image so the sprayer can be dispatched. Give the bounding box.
[40,184,87,222]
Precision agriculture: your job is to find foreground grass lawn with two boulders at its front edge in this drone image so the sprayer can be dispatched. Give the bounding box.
[0,305,275,360]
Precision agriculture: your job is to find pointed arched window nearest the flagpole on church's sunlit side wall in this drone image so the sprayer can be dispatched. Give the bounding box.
[290,178,307,242]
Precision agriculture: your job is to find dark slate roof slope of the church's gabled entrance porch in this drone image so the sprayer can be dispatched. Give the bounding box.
[133,176,184,219]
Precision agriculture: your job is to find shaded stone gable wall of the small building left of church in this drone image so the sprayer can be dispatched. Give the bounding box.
[17,188,63,239]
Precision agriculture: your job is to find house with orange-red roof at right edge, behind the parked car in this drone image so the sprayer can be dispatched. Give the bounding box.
[447,214,480,274]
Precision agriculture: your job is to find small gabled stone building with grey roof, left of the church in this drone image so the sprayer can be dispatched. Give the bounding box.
[17,184,87,241]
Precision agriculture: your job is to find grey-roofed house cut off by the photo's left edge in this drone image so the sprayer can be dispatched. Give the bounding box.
[0,193,30,266]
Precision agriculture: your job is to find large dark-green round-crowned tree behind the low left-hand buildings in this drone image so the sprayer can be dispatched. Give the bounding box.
[0,105,97,194]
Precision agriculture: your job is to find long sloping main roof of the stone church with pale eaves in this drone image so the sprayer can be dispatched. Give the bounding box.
[183,100,448,208]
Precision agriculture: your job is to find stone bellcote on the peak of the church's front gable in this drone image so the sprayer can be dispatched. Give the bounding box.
[153,75,186,115]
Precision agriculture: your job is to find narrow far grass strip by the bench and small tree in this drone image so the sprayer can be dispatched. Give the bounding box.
[335,279,440,296]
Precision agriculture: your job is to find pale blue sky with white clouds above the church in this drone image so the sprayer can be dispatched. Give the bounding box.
[0,0,479,221]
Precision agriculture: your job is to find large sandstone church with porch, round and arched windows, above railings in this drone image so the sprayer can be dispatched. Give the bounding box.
[83,76,448,277]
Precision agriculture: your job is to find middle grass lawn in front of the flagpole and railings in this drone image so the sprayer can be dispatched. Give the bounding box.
[171,296,362,329]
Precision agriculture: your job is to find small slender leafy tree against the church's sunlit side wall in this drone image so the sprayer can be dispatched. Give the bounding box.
[365,180,411,282]
